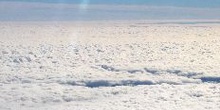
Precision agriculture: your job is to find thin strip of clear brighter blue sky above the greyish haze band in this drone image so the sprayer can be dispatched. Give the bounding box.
[0,0,220,8]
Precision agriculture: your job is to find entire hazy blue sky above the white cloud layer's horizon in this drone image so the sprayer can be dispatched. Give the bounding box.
[0,0,220,21]
